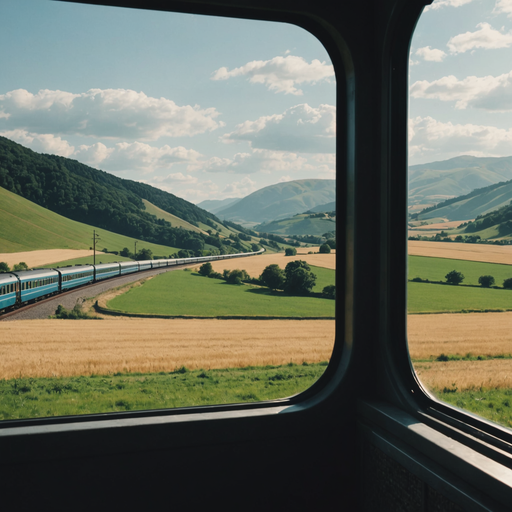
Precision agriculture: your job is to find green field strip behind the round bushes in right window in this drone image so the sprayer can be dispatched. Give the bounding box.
[408,256,512,286]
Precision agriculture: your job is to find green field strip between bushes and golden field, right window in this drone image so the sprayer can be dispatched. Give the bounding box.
[407,282,512,313]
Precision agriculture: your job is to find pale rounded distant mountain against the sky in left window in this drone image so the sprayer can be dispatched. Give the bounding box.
[217,179,336,225]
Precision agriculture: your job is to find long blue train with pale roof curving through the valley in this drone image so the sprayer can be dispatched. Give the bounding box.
[0,249,265,313]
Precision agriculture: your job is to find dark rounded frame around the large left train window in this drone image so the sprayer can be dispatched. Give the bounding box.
[0,0,355,434]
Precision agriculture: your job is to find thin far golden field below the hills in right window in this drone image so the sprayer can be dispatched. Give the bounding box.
[408,240,512,265]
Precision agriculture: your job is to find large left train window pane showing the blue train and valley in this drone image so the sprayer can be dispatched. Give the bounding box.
[0,0,336,419]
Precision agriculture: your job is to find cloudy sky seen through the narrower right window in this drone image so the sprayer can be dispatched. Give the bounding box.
[408,0,512,165]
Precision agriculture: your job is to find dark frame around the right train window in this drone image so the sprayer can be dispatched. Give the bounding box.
[380,0,512,468]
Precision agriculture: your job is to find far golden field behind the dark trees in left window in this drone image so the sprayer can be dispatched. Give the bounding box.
[208,247,336,277]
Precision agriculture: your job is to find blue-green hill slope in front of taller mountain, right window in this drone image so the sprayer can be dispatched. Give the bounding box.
[417,180,512,220]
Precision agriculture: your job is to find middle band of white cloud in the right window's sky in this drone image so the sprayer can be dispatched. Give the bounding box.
[410,71,512,112]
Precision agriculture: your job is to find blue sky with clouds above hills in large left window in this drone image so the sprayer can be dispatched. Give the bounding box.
[0,0,336,203]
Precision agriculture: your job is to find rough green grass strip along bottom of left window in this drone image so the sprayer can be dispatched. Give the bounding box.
[0,362,327,420]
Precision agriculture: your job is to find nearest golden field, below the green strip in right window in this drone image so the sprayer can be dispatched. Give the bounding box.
[407,312,512,358]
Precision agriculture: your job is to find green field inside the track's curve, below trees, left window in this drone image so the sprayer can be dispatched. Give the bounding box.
[108,270,335,318]
